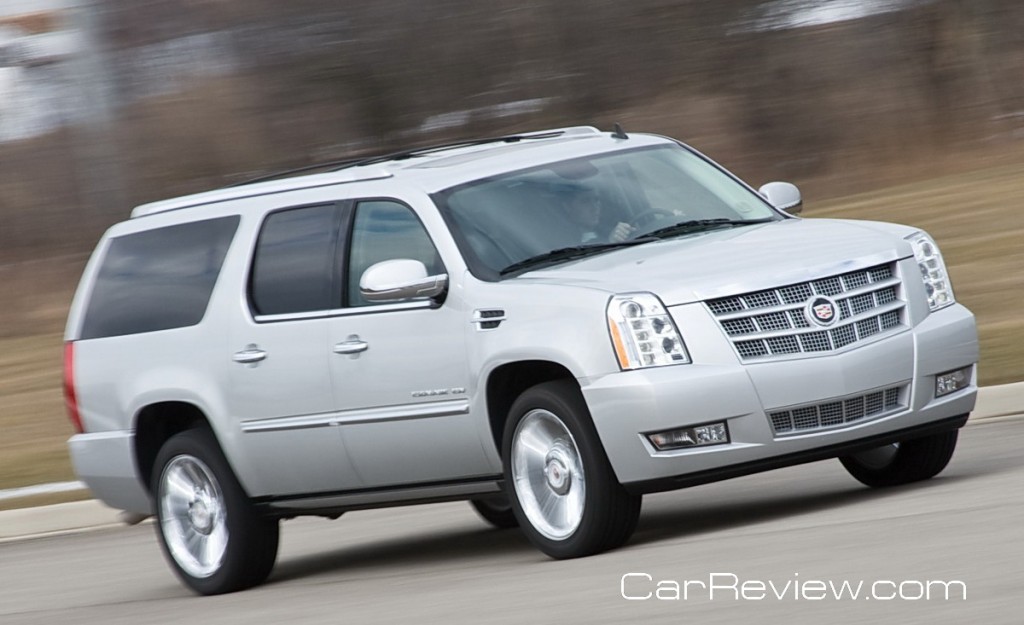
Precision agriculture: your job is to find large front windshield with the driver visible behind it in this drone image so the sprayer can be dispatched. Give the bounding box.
[435,145,783,279]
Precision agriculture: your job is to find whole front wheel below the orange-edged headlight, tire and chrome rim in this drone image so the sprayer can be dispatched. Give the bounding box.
[502,380,641,559]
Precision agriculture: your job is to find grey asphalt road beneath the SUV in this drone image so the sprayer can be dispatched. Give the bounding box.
[0,419,1024,625]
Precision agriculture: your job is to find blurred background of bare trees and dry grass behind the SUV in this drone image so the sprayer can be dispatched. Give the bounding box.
[0,0,1024,488]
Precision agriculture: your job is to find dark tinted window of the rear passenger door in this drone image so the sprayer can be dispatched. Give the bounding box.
[250,204,341,315]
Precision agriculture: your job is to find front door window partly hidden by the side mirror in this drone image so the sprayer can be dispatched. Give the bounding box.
[348,201,444,306]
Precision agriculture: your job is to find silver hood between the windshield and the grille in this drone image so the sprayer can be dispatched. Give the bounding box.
[519,219,915,306]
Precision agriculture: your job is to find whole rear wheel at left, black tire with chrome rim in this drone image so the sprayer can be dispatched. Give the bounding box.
[153,429,280,594]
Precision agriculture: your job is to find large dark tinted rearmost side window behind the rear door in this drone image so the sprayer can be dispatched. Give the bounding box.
[81,216,239,339]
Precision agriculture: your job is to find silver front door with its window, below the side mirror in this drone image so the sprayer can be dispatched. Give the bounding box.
[329,200,493,488]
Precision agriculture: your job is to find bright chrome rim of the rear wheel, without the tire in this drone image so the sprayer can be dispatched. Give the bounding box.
[159,455,228,578]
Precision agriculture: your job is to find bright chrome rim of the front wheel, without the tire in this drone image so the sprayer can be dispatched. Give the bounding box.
[511,409,587,540]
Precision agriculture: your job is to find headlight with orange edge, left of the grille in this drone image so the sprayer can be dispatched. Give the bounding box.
[608,293,690,370]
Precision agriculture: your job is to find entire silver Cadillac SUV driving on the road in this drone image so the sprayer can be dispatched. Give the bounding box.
[65,127,978,593]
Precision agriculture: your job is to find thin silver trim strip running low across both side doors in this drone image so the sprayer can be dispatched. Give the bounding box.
[242,399,469,433]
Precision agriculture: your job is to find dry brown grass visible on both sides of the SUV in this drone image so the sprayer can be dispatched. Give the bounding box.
[0,164,1024,493]
